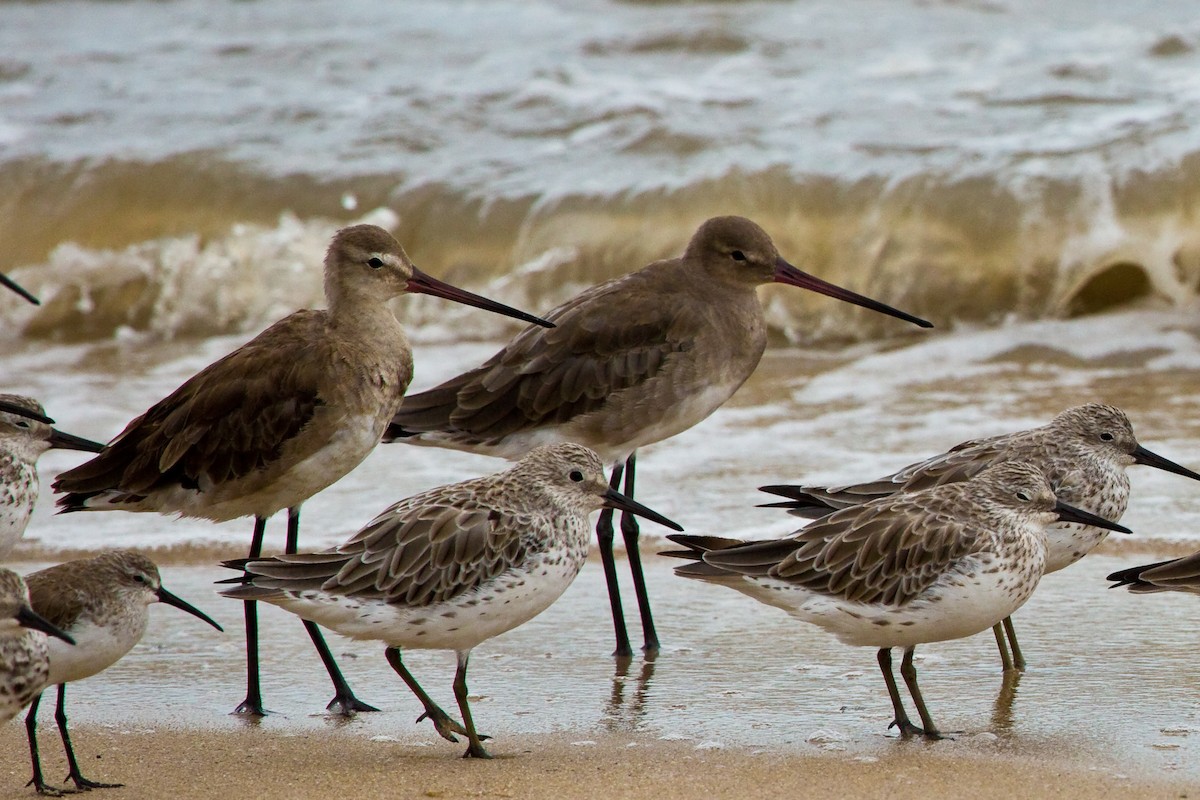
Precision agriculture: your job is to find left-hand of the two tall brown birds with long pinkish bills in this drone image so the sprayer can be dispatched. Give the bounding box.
[54,225,548,716]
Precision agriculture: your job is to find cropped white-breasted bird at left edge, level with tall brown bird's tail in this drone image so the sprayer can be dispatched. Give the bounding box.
[0,395,104,559]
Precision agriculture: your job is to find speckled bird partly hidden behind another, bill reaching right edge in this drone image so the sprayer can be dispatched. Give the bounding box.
[761,403,1200,670]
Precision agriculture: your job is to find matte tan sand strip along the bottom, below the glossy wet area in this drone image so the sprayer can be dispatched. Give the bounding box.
[0,724,1194,800]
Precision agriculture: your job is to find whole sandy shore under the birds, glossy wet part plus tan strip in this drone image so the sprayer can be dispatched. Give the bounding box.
[0,553,1200,800]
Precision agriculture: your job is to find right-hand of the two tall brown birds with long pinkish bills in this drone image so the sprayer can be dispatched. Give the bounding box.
[384,217,931,656]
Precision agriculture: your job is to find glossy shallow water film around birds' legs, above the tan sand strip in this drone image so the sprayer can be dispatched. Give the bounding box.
[12,555,1200,777]
